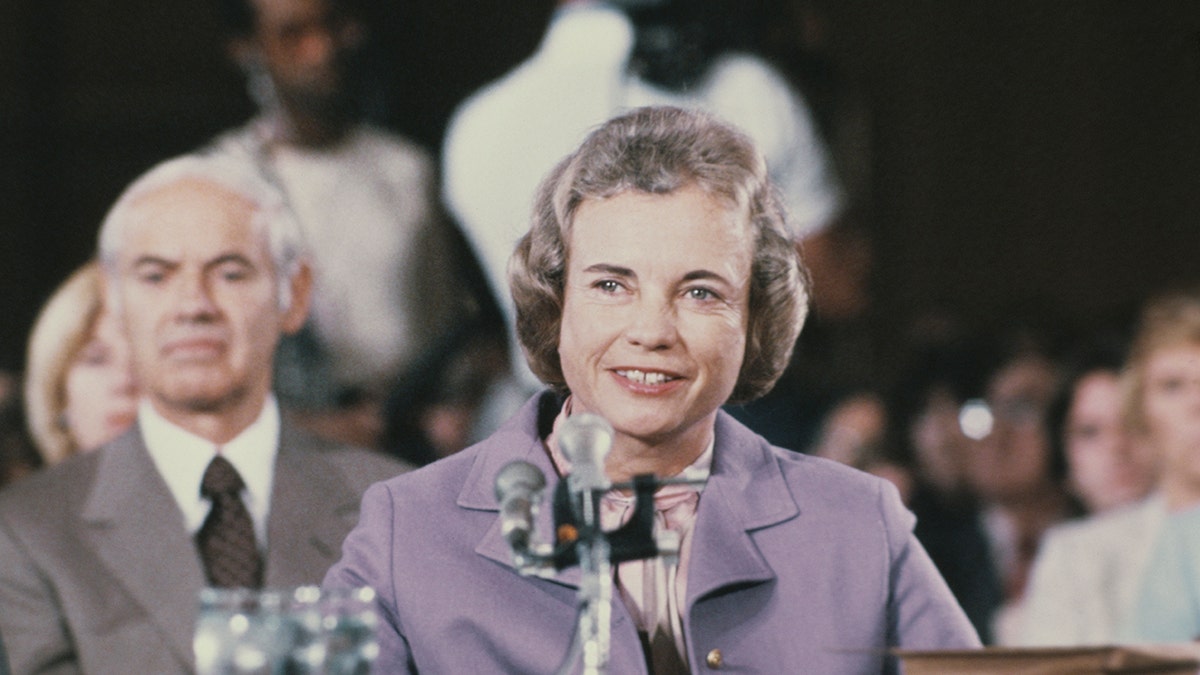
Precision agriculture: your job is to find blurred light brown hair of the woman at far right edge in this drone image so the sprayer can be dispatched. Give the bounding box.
[1122,288,1200,431]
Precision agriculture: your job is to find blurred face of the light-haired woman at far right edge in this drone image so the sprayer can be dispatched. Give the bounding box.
[1142,345,1200,506]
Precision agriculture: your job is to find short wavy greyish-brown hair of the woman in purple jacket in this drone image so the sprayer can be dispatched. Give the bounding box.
[509,106,809,402]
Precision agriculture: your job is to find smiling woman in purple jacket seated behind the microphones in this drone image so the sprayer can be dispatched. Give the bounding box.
[325,108,978,674]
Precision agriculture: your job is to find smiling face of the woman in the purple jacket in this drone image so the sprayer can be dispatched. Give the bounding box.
[558,186,752,444]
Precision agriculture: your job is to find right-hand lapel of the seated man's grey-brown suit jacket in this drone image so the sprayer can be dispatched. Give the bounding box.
[266,422,360,587]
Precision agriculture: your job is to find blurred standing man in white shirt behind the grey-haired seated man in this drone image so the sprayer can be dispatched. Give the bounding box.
[211,0,505,447]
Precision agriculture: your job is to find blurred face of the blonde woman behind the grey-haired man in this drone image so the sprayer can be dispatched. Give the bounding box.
[65,312,137,452]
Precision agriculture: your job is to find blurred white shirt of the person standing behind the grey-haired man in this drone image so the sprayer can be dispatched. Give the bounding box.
[208,115,464,400]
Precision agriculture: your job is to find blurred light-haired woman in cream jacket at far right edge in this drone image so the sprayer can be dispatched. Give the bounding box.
[1024,293,1200,645]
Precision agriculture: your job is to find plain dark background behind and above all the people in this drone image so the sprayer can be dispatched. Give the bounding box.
[0,0,1200,369]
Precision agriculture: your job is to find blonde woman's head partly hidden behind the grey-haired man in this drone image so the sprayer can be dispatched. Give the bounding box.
[24,262,137,465]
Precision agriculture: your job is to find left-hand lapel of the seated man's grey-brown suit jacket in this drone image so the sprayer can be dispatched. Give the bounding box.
[83,429,204,664]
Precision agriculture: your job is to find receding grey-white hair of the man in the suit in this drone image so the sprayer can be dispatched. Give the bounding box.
[98,153,307,309]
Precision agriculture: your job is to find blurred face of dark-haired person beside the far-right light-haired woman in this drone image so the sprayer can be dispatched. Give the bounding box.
[1063,370,1154,512]
